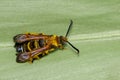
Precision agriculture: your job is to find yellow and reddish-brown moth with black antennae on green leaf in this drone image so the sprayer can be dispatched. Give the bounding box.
[13,20,79,63]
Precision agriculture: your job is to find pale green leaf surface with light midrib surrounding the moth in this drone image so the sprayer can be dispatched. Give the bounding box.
[0,0,120,80]
